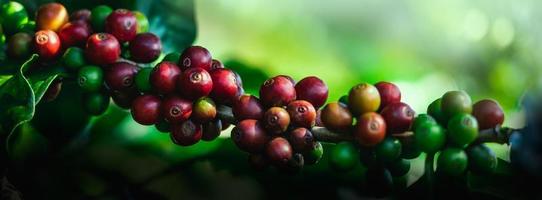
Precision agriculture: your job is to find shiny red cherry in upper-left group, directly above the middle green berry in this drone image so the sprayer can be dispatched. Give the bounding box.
[85,33,121,65]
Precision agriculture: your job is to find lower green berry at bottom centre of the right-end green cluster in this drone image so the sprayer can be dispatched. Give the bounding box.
[437,148,468,176]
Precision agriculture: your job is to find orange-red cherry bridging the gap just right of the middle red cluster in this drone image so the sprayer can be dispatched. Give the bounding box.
[321,102,353,132]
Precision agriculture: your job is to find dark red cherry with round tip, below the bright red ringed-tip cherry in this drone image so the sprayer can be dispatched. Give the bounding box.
[162,96,192,123]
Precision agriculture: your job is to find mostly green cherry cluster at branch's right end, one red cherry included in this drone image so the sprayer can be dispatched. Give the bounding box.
[413,91,504,176]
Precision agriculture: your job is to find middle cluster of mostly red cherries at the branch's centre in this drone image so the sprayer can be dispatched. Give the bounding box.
[231,75,328,171]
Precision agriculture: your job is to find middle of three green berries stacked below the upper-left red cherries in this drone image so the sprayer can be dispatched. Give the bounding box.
[77,65,104,92]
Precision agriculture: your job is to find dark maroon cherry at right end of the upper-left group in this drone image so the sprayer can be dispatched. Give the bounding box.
[130,33,162,63]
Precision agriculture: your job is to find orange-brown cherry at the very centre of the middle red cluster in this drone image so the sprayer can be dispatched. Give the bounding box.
[263,107,290,135]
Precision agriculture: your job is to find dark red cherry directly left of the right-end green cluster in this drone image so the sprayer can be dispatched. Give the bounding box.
[380,102,416,134]
